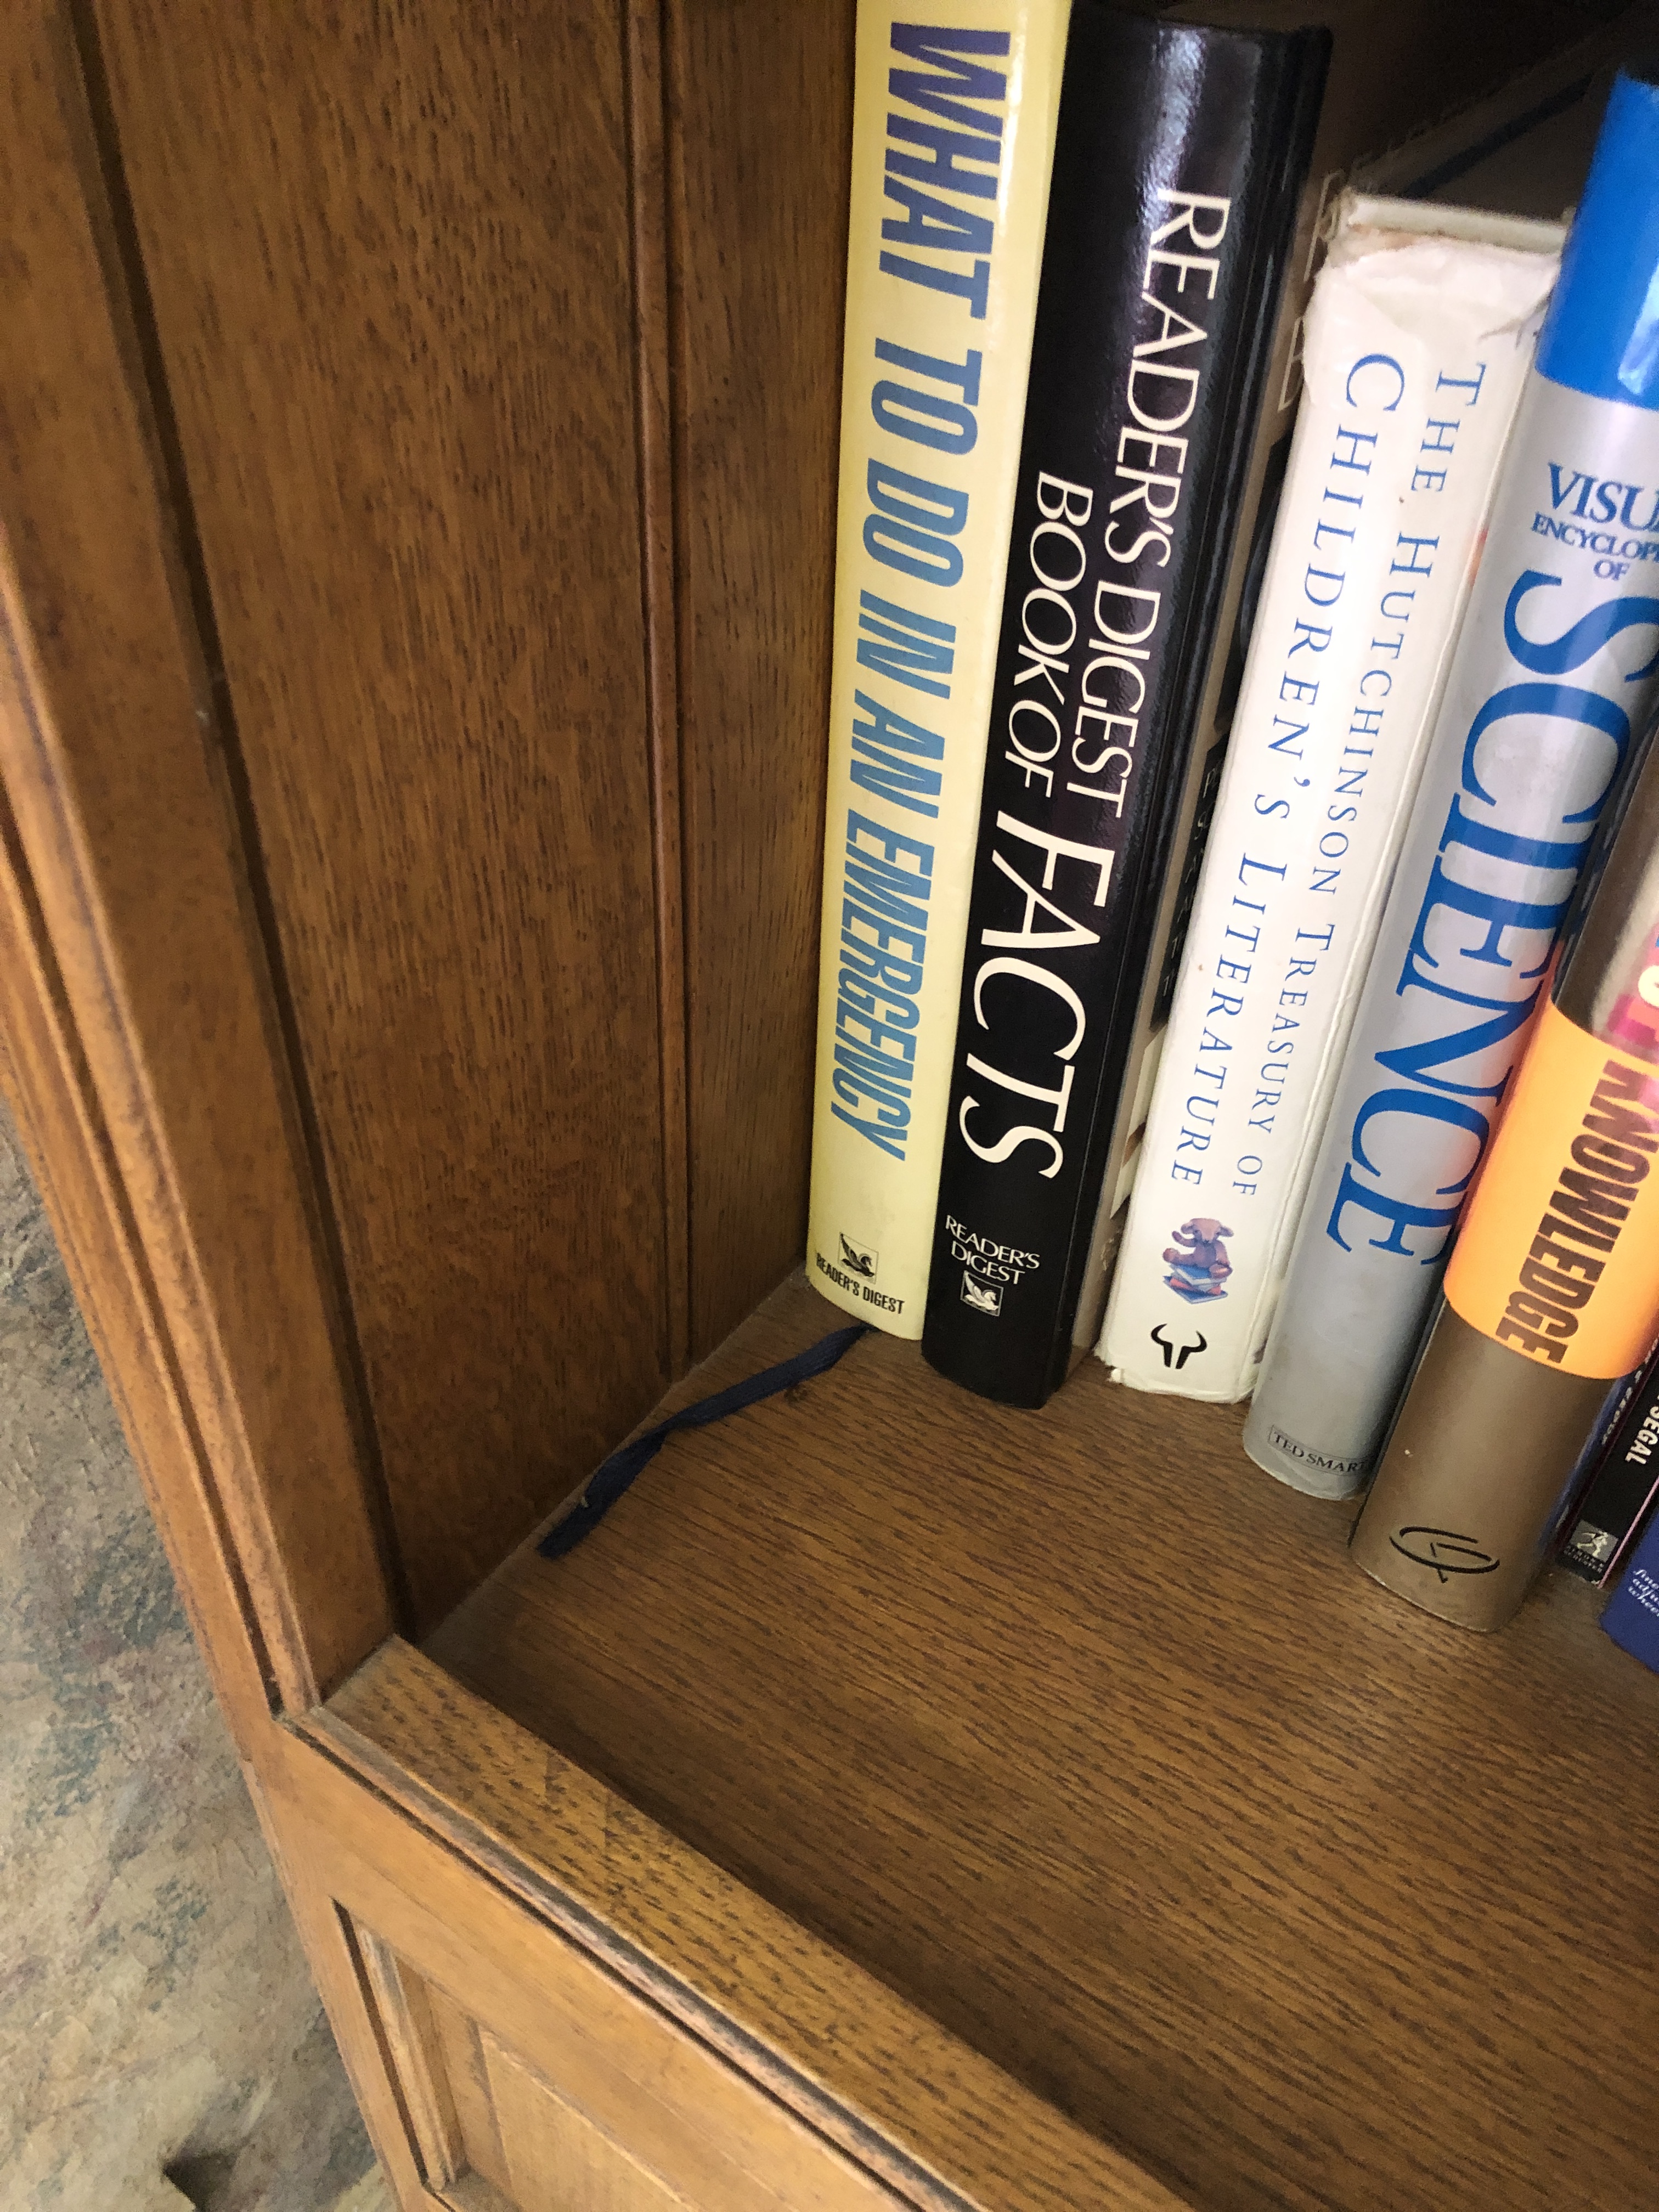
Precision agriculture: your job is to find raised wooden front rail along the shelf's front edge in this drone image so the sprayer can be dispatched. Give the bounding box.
[320,1639,1181,2212]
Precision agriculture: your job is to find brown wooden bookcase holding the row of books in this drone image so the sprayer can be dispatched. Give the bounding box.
[0,0,1659,2212]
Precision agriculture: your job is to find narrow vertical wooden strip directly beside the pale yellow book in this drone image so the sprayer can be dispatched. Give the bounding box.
[668,0,854,1358]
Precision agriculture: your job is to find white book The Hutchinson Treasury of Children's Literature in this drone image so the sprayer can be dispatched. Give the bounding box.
[1099,201,1560,1400]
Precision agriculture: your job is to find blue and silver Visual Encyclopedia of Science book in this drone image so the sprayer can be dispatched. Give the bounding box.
[1243,73,1659,1498]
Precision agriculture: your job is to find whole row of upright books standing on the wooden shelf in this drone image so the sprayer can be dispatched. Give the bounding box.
[808,0,1659,1663]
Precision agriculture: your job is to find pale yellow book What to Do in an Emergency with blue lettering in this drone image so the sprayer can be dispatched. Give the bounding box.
[808,0,1068,1336]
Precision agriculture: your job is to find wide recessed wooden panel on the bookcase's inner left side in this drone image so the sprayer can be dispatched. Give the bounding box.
[97,0,668,1621]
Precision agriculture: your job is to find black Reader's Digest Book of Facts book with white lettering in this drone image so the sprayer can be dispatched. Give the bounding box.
[922,0,1329,1407]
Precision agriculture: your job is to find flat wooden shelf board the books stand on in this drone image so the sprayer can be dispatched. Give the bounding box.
[427,1276,1659,2212]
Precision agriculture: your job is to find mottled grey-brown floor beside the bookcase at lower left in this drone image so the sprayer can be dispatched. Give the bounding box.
[0,1110,382,2212]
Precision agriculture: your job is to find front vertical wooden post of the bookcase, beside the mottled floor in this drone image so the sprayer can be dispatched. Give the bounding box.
[0,0,392,1707]
